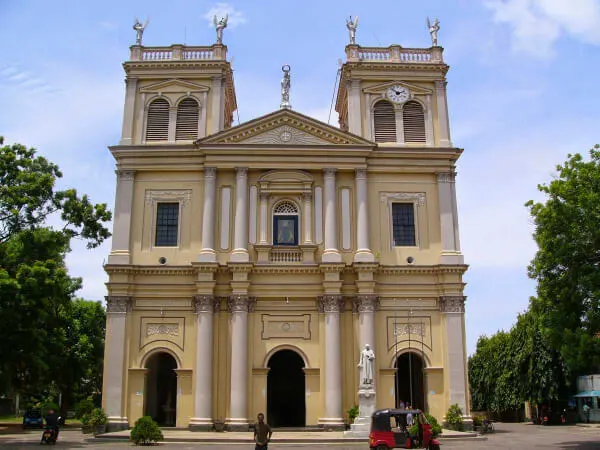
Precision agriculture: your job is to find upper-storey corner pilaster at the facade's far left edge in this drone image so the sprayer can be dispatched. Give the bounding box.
[108,170,135,264]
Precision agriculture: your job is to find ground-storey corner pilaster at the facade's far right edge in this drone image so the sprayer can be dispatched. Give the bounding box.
[439,295,470,416]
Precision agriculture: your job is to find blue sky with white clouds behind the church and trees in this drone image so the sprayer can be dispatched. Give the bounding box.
[0,0,600,353]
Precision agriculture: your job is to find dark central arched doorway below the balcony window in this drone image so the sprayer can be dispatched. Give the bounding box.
[267,350,306,427]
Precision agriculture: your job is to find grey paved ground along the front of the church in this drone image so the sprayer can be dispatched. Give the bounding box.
[0,424,600,450]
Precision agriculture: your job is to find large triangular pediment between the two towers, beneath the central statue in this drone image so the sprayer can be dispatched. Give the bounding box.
[197,109,375,146]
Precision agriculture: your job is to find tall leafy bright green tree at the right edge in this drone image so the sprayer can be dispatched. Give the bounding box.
[527,145,600,375]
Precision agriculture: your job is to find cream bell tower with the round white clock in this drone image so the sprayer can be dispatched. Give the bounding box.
[335,42,452,148]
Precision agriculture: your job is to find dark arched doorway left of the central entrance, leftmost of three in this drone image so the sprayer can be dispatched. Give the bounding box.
[144,352,177,427]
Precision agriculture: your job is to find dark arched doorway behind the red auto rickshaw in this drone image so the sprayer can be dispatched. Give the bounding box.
[396,352,427,410]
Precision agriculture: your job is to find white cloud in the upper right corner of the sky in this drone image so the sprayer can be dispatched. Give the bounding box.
[484,0,600,58]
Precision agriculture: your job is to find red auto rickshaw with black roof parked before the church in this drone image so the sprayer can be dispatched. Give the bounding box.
[369,409,440,450]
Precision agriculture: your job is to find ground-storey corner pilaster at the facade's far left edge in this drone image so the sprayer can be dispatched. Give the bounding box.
[102,296,131,431]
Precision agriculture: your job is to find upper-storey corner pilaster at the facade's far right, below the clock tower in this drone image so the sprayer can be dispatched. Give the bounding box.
[437,172,464,264]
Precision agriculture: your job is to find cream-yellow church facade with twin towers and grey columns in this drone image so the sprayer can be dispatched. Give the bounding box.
[103,26,469,430]
